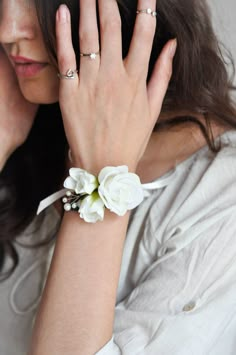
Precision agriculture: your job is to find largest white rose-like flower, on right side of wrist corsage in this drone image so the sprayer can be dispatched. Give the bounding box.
[98,166,143,216]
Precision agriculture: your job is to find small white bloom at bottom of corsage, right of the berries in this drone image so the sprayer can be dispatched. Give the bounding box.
[78,192,105,223]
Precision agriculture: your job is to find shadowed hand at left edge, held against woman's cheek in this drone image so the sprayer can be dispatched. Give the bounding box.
[0,45,38,170]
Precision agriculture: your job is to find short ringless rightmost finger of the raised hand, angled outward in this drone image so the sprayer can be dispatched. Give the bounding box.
[148,39,177,120]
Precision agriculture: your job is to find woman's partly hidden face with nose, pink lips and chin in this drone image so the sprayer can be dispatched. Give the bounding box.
[0,0,59,104]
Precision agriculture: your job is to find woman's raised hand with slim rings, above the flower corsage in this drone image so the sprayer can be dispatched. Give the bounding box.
[56,0,176,173]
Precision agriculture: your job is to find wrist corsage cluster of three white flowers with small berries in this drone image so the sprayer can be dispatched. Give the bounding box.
[62,166,143,223]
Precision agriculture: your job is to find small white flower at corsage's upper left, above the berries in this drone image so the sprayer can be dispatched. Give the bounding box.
[64,168,98,195]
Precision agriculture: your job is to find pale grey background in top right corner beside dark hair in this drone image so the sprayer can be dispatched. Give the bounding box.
[207,0,236,84]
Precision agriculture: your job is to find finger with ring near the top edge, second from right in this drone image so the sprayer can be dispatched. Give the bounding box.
[125,0,156,80]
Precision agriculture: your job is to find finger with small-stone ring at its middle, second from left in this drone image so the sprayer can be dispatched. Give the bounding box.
[79,0,100,82]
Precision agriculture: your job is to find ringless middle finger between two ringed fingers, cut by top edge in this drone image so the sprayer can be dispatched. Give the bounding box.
[98,0,123,70]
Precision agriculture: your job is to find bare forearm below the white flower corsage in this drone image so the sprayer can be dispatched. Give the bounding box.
[30,212,128,355]
